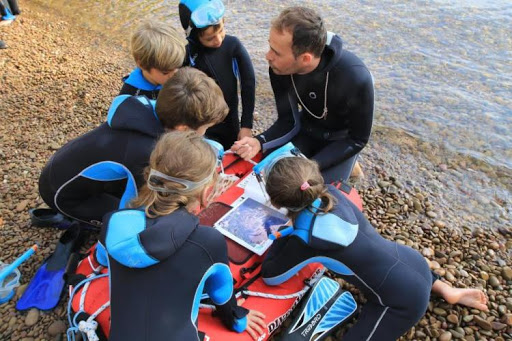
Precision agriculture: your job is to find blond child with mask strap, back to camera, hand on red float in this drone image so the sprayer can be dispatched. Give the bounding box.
[100,131,266,341]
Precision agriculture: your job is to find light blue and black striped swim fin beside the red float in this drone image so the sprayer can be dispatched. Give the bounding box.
[280,277,357,341]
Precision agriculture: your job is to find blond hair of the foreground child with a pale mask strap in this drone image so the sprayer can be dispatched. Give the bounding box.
[130,131,217,218]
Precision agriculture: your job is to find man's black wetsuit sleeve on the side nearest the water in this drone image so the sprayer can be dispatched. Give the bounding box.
[312,67,374,169]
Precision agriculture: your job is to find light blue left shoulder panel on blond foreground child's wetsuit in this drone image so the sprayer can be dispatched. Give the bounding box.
[105,210,158,268]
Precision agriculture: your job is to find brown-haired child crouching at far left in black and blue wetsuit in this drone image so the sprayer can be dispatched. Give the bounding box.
[37,67,228,227]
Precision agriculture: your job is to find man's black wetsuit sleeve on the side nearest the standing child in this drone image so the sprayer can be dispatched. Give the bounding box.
[256,68,300,150]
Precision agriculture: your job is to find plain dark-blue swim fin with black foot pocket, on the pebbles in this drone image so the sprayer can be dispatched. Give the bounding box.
[16,223,82,310]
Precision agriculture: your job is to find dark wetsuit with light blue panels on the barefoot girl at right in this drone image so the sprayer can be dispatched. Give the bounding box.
[262,186,436,341]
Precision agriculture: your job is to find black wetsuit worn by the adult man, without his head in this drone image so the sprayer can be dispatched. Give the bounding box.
[256,33,374,183]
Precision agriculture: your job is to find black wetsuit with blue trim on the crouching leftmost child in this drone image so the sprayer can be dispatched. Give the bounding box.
[39,95,164,226]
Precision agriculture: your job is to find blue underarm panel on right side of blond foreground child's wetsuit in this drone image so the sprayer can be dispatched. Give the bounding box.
[190,263,233,324]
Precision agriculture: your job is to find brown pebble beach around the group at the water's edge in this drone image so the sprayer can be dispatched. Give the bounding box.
[0,1,512,341]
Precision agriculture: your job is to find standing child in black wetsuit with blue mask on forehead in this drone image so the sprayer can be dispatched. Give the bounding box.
[179,0,256,150]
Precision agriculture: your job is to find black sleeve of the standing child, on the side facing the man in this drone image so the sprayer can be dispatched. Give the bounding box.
[235,39,256,129]
